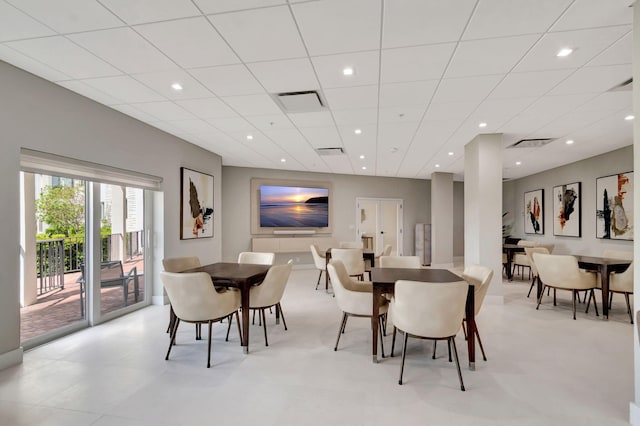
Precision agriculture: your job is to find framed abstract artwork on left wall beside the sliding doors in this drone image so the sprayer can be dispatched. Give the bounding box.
[180,167,213,240]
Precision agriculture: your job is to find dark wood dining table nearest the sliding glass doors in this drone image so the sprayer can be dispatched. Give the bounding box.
[184,262,271,353]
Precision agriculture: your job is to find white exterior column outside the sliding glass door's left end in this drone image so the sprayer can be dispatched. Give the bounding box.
[20,172,38,307]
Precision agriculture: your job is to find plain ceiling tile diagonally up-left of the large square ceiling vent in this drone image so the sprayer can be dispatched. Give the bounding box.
[189,65,264,96]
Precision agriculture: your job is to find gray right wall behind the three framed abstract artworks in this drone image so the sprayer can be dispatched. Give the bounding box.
[502,146,633,256]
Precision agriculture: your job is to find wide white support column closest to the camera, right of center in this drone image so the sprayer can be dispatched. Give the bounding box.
[464,134,503,303]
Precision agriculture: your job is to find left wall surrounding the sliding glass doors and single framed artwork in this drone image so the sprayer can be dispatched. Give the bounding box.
[0,61,222,368]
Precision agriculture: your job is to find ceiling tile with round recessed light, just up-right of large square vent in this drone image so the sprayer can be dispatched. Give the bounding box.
[311,51,380,89]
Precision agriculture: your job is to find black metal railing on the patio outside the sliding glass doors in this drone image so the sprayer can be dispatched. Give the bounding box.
[36,231,144,296]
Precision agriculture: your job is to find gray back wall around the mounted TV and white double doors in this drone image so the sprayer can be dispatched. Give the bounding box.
[222,166,464,263]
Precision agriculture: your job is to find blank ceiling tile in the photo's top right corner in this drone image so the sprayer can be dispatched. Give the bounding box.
[551,0,633,31]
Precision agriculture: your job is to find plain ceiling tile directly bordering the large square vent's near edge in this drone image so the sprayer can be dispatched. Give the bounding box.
[247,58,320,93]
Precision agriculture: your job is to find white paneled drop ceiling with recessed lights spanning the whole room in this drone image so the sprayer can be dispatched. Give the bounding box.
[0,0,633,179]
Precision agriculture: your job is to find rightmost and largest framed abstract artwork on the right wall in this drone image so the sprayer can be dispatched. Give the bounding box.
[596,172,633,240]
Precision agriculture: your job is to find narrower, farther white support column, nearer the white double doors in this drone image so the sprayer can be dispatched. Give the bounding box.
[431,173,453,268]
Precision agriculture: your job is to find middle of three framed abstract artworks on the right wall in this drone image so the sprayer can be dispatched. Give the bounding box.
[553,182,582,237]
